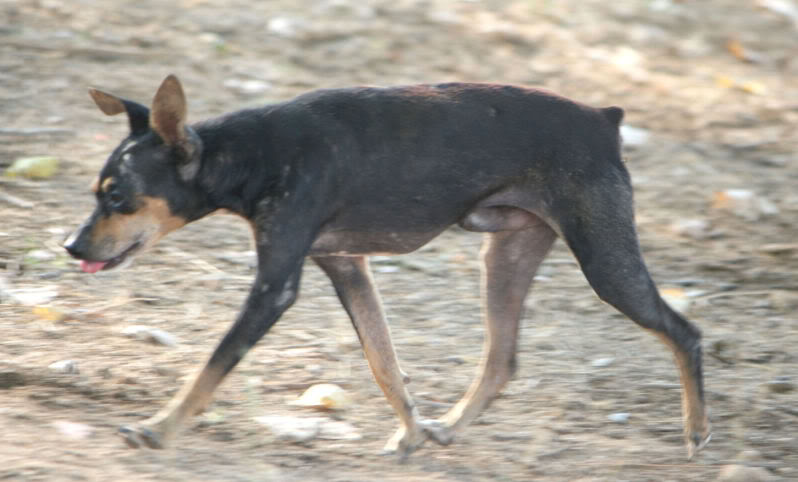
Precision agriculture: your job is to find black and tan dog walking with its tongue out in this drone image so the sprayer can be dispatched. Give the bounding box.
[65,76,710,456]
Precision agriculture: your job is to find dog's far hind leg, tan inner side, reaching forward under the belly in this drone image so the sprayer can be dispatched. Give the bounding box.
[427,218,556,444]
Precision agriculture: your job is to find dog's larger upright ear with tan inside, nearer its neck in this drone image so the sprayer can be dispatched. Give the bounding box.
[150,75,202,181]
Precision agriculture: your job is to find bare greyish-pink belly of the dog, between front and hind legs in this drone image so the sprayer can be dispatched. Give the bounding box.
[308,229,443,256]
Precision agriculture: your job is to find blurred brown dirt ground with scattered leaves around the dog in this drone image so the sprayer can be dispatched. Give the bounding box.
[0,0,798,481]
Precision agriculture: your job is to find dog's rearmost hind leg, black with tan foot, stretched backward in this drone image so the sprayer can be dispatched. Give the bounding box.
[550,167,710,458]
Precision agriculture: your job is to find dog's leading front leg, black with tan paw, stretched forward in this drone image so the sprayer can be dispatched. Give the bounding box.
[119,262,301,448]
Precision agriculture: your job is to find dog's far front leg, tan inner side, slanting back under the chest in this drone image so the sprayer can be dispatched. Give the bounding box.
[313,256,427,458]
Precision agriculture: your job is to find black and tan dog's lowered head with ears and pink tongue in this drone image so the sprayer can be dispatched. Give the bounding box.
[64,75,202,273]
